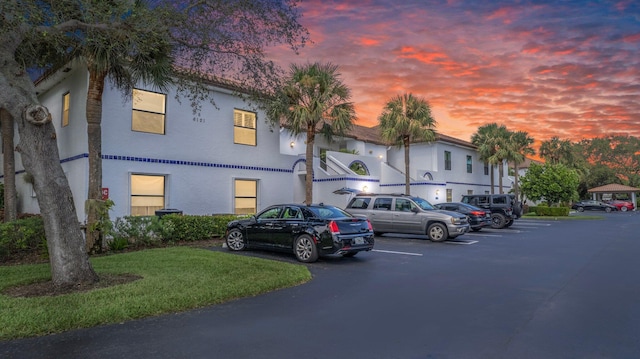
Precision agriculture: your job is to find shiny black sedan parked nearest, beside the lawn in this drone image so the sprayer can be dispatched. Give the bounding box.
[225,204,373,263]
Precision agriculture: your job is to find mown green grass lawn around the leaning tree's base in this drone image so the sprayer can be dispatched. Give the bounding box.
[0,247,311,340]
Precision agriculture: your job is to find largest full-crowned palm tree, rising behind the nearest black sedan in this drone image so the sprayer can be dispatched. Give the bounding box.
[267,62,355,204]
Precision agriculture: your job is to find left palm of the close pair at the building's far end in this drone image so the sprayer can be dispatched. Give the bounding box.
[471,123,508,194]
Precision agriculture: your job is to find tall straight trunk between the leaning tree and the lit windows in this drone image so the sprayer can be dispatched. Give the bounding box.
[86,70,106,253]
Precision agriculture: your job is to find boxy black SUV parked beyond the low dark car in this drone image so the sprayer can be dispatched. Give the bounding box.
[461,194,522,228]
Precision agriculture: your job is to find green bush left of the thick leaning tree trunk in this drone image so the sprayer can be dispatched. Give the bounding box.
[0,216,47,259]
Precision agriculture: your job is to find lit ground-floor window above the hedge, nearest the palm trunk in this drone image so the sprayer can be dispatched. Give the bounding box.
[131,174,165,216]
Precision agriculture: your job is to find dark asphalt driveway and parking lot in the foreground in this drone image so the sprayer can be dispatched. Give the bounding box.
[0,212,640,359]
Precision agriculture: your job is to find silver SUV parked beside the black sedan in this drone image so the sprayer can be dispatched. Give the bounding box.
[345,194,469,242]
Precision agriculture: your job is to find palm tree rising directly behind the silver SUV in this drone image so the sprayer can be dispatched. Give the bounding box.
[378,93,436,194]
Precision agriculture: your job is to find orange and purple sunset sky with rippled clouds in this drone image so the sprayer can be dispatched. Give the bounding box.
[273,0,640,150]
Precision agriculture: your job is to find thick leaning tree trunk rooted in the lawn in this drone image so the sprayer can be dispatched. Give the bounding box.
[0,54,98,287]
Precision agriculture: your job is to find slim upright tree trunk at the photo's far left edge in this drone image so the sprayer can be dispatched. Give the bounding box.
[0,109,18,222]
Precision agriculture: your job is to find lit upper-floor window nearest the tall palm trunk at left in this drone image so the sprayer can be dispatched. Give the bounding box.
[131,89,167,135]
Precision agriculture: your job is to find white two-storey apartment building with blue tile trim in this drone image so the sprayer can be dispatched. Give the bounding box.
[0,66,511,222]
